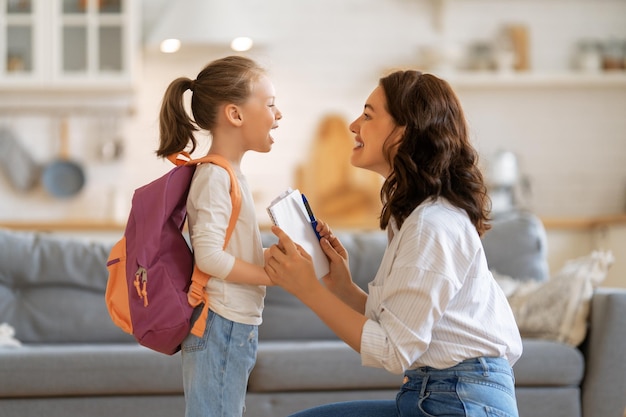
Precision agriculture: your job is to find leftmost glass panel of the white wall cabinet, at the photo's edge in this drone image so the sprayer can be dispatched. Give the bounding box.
[3,0,35,74]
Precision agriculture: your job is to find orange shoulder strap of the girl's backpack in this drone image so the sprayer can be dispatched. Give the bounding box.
[178,154,241,337]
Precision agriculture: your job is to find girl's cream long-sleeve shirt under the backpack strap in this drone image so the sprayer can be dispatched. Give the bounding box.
[187,164,265,325]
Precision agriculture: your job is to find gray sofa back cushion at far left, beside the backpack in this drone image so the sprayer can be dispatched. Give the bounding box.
[0,230,134,343]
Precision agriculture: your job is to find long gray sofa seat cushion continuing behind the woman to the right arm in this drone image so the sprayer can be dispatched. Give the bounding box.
[248,339,585,392]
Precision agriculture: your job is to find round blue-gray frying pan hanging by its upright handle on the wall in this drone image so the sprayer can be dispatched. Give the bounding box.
[41,119,85,198]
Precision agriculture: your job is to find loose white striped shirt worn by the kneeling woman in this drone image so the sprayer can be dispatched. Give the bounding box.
[361,198,522,373]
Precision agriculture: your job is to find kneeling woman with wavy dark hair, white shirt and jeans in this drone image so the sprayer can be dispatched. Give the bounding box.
[266,71,522,417]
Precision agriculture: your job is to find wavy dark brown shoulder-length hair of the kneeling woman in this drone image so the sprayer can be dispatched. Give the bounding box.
[380,70,491,235]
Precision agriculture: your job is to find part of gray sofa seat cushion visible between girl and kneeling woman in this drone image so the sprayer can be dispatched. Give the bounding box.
[248,340,402,392]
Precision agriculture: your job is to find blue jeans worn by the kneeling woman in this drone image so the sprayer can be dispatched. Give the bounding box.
[292,357,518,417]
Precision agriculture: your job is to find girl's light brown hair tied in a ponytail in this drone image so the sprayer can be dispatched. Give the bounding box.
[156,56,265,158]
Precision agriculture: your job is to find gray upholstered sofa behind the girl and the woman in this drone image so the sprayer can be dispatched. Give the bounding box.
[0,213,626,417]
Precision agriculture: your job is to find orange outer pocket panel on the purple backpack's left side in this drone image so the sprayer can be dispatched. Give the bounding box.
[104,237,133,334]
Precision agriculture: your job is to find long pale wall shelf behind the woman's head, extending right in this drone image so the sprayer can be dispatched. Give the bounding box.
[441,71,626,89]
